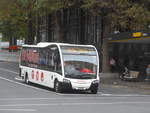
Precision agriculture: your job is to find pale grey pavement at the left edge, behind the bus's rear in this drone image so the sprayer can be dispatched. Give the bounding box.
[0,50,19,62]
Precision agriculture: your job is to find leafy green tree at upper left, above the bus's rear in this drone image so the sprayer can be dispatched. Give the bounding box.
[0,0,61,44]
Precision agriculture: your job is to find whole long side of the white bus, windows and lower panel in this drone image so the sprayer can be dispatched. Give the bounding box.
[20,45,63,88]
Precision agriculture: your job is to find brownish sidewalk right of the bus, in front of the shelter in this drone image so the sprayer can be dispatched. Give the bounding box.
[100,73,150,94]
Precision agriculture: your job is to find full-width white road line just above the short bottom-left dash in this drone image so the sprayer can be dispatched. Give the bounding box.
[0,102,150,107]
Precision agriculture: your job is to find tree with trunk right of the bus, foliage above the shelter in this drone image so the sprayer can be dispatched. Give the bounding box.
[82,0,150,71]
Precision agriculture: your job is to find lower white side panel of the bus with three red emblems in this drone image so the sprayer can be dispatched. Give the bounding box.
[20,66,62,88]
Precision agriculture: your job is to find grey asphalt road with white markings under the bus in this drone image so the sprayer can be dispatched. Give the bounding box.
[0,62,150,113]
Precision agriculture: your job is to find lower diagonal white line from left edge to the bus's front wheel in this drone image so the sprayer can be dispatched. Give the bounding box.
[0,77,49,93]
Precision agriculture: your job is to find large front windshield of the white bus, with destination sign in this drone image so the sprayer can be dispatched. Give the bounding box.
[61,46,98,79]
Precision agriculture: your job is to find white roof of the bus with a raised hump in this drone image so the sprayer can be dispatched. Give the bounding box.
[22,42,94,48]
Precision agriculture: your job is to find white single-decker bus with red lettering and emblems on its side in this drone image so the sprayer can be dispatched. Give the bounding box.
[19,42,99,94]
